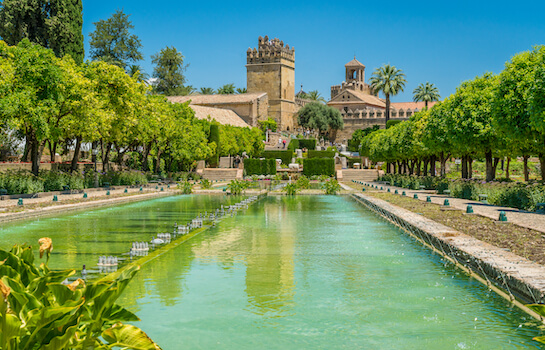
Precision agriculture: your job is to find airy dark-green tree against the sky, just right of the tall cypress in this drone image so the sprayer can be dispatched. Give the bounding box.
[89,10,143,69]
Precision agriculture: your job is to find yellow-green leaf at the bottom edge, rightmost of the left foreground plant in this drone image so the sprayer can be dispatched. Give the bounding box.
[102,323,161,350]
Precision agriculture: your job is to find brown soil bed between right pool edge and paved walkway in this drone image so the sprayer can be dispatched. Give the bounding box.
[365,191,545,265]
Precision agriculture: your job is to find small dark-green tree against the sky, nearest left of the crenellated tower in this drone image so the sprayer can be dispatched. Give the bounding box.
[151,46,187,96]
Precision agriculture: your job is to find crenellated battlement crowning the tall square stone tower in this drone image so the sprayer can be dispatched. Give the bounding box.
[246,36,295,64]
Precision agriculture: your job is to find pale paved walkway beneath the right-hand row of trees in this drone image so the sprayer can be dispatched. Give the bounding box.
[346,181,545,233]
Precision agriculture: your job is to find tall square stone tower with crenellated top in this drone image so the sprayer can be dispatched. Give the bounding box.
[246,36,296,130]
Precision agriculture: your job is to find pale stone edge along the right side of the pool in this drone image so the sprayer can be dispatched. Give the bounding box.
[352,193,545,321]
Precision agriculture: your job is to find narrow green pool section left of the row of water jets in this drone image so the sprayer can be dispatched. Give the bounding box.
[0,195,240,269]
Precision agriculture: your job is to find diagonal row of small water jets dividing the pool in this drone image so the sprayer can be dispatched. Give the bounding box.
[86,197,260,278]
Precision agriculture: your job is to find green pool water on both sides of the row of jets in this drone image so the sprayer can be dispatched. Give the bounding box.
[0,196,540,349]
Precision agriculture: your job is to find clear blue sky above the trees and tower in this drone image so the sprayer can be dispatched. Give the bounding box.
[83,0,545,102]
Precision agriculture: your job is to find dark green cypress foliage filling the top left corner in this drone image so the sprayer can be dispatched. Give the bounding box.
[0,0,84,63]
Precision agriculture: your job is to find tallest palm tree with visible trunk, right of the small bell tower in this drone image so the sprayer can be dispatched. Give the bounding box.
[369,64,407,123]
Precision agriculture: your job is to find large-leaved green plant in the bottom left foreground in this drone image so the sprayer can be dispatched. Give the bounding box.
[0,238,160,350]
